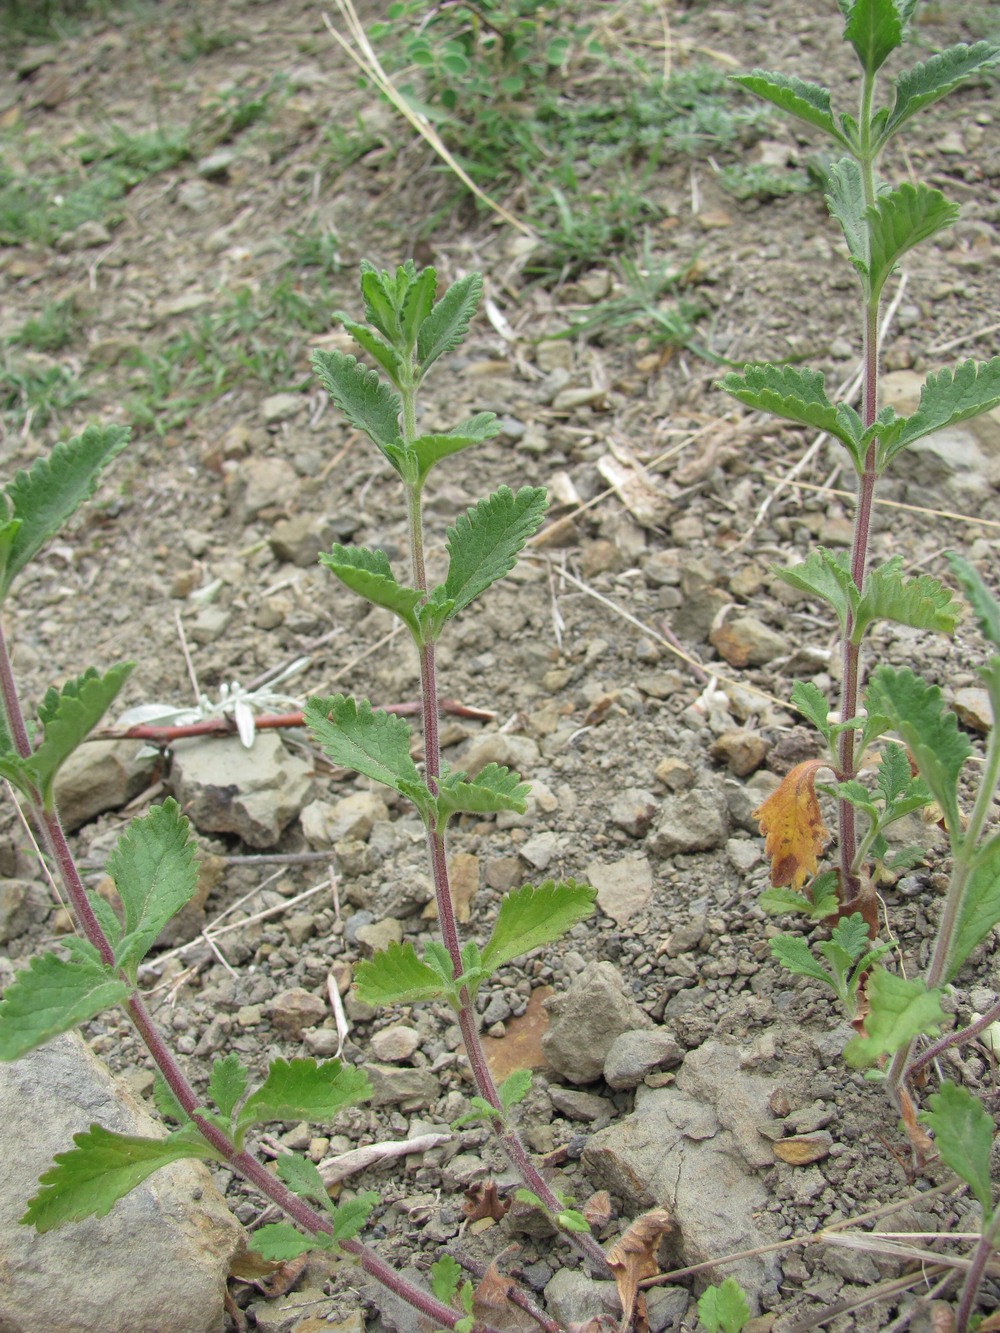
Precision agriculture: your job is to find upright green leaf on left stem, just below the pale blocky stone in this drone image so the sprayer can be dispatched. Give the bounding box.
[107,798,197,970]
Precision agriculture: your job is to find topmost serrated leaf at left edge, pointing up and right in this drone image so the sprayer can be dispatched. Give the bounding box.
[0,425,128,601]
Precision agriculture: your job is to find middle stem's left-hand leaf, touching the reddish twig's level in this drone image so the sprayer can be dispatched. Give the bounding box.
[304,694,431,802]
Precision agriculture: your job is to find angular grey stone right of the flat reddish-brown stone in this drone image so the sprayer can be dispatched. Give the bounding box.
[541,962,652,1084]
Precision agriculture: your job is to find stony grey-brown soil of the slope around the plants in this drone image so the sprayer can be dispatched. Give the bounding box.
[0,0,1000,1333]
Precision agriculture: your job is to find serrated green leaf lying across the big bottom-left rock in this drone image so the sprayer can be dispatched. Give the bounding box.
[19,1125,215,1232]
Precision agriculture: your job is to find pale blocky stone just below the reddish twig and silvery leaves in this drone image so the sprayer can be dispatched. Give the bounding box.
[171,732,312,848]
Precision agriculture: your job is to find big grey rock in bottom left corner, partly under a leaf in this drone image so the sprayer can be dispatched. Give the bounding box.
[0,1033,244,1333]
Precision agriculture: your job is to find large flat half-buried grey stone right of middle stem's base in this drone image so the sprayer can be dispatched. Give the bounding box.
[583,1042,780,1294]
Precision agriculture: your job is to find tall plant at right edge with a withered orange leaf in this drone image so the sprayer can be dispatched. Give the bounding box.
[721,0,1000,1333]
